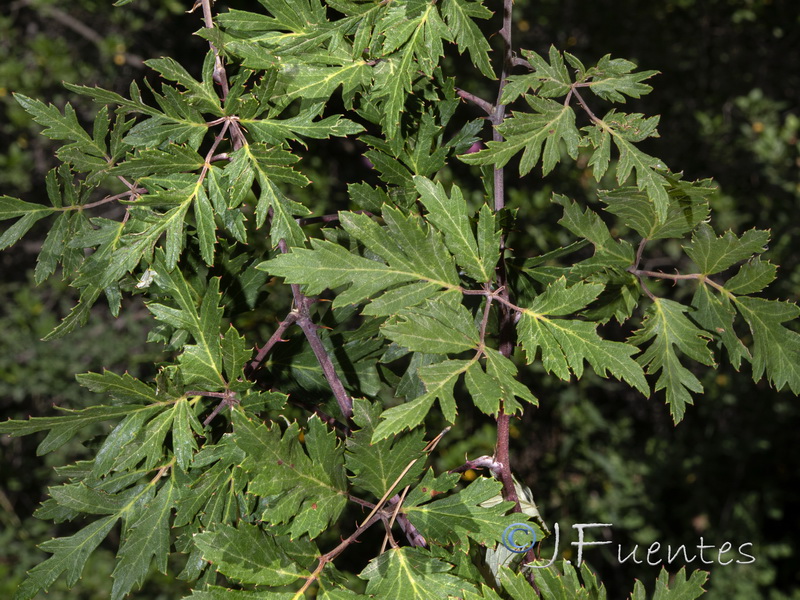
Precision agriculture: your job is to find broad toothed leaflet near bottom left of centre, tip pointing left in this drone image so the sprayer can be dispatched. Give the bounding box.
[194,521,306,586]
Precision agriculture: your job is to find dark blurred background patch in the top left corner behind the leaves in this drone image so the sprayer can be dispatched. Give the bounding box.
[0,0,190,196]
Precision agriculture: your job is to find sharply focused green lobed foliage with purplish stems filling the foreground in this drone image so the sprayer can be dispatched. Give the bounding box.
[0,0,800,600]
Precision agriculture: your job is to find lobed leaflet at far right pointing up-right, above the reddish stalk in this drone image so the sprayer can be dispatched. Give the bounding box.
[684,223,769,275]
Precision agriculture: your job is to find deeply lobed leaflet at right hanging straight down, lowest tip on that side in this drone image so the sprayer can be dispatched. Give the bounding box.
[628,298,715,423]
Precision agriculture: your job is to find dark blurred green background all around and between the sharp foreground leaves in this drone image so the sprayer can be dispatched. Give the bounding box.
[0,0,800,600]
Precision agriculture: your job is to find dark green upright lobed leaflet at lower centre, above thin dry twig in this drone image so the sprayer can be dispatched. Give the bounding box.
[345,398,425,498]
